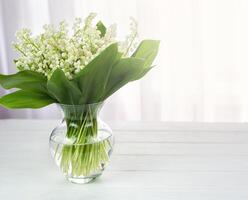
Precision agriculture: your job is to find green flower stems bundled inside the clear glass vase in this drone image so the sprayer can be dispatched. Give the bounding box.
[55,109,111,177]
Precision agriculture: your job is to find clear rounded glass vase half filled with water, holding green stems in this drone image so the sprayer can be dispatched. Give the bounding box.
[50,103,114,183]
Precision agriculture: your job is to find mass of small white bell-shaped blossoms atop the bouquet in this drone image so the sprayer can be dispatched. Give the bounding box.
[14,13,137,79]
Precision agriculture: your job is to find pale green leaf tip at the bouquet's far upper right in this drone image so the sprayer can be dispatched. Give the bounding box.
[132,40,159,68]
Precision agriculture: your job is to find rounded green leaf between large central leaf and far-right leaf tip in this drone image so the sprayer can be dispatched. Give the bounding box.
[102,57,144,100]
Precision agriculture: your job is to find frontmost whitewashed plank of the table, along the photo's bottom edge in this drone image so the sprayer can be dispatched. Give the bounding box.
[0,184,248,200]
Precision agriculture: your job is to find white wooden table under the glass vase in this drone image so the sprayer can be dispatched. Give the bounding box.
[0,120,248,200]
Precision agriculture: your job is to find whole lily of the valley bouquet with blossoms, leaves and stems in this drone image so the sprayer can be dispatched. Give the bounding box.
[0,13,159,184]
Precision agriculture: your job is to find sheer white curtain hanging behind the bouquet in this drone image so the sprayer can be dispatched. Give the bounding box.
[0,0,248,122]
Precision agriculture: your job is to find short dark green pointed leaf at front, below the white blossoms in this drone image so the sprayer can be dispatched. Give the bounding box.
[47,69,81,105]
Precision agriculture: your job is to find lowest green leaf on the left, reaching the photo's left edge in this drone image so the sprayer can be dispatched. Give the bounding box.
[0,90,55,108]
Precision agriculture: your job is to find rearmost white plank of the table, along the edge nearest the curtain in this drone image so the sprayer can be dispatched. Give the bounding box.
[0,119,248,133]
